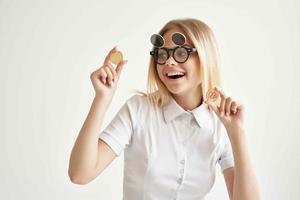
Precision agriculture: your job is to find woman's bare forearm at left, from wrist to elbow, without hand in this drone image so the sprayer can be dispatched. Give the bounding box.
[69,96,110,179]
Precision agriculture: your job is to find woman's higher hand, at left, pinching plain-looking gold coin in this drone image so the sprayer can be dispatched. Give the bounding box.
[90,47,127,99]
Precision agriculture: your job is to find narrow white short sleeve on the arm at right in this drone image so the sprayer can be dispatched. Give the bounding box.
[218,127,234,173]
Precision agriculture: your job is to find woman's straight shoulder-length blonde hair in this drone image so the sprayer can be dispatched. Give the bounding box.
[137,18,221,106]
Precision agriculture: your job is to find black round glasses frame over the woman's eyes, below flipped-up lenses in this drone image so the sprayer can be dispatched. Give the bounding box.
[150,46,197,65]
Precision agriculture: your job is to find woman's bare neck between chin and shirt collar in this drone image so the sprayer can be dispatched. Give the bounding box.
[172,85,202,110]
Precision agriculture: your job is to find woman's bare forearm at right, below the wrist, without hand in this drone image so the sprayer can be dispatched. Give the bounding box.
[228,129,260,200]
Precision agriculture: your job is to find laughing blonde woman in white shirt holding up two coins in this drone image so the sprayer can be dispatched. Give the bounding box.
[69,19,260,200]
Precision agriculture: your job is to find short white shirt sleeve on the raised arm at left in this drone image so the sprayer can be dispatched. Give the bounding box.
[99,97,133,156]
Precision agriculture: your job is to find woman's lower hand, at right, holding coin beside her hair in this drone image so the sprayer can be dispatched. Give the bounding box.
[205,87,244,133]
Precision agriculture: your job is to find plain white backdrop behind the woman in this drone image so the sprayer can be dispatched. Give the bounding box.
[0,0,300,200]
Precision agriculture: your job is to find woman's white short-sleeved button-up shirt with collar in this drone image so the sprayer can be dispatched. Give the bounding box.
[99,95,234,200]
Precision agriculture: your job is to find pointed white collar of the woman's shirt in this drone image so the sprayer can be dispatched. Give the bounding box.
[163,97,213,131]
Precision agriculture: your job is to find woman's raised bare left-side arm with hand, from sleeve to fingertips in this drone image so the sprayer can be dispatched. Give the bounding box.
[68,47,127,185]
